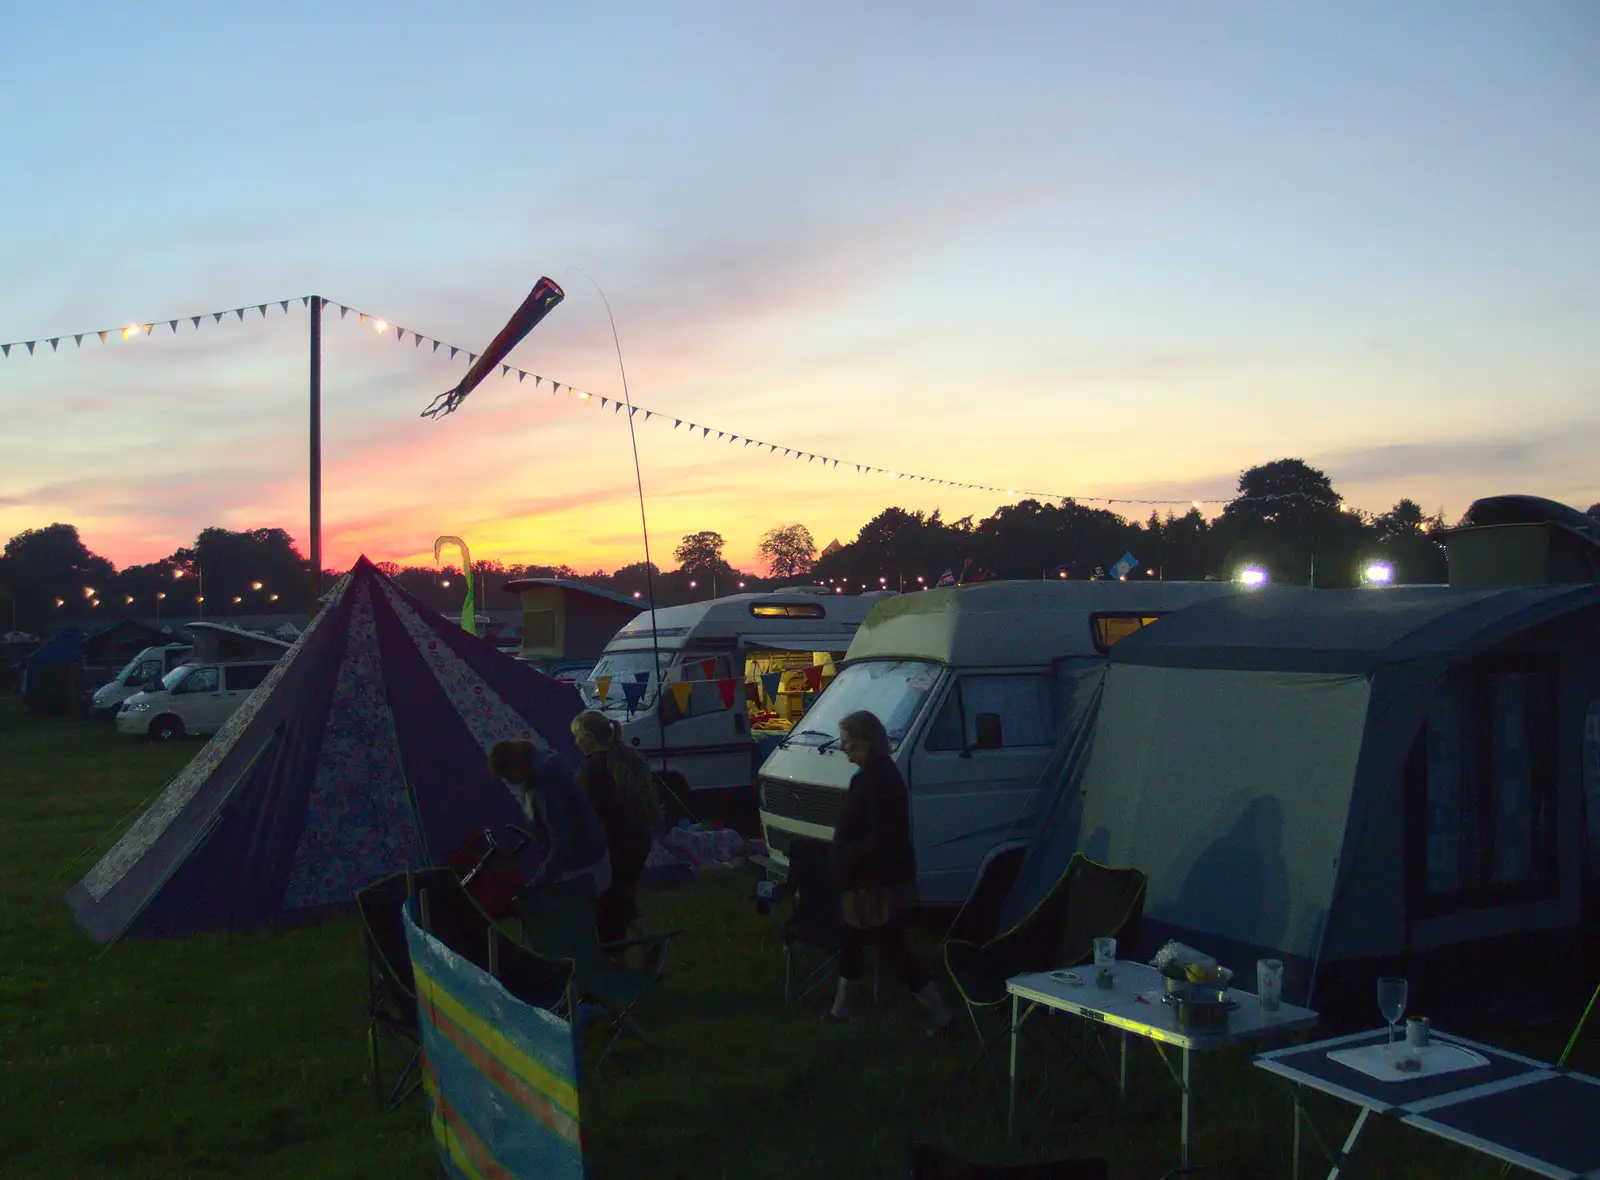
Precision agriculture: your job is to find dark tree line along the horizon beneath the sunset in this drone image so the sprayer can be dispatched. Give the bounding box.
[0,459,1600,632]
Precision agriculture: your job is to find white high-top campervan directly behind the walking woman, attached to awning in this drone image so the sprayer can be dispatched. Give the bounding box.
[758,580,1240,905]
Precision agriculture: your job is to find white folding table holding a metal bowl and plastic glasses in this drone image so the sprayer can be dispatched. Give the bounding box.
[1005,959,1317,1167]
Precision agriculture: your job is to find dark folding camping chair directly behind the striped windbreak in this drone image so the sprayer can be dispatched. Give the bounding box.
[355,868,573,1111]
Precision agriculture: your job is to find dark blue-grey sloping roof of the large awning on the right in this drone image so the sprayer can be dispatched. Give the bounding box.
[1112,585,1600,673]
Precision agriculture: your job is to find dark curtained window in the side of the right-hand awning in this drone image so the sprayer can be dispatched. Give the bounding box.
[1406,660,1558,915]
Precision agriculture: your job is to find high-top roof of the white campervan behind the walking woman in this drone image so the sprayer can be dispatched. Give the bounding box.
[850,580,1240,667]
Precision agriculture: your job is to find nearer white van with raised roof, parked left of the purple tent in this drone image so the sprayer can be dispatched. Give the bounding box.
[117,622,290,742]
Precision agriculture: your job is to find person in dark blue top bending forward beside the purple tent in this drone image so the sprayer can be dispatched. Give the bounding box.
[490,740,611,897]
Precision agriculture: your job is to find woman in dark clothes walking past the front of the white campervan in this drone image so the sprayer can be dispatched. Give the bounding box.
[829,710,955,1036]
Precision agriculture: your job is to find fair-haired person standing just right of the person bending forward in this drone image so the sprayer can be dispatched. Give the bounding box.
[573,708,661,942]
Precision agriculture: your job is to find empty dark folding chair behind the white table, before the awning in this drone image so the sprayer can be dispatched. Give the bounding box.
[944,852,1147,1087]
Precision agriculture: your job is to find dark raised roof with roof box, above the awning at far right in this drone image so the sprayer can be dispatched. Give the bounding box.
[1445,496,1600,587]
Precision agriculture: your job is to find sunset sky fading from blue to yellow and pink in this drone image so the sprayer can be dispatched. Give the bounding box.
[0,0,1600,571]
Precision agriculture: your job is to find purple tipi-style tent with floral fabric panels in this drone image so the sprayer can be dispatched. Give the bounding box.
[67,558,582,942]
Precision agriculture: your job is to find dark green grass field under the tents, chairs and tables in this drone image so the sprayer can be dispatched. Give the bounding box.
[0,700,1600,1180]
